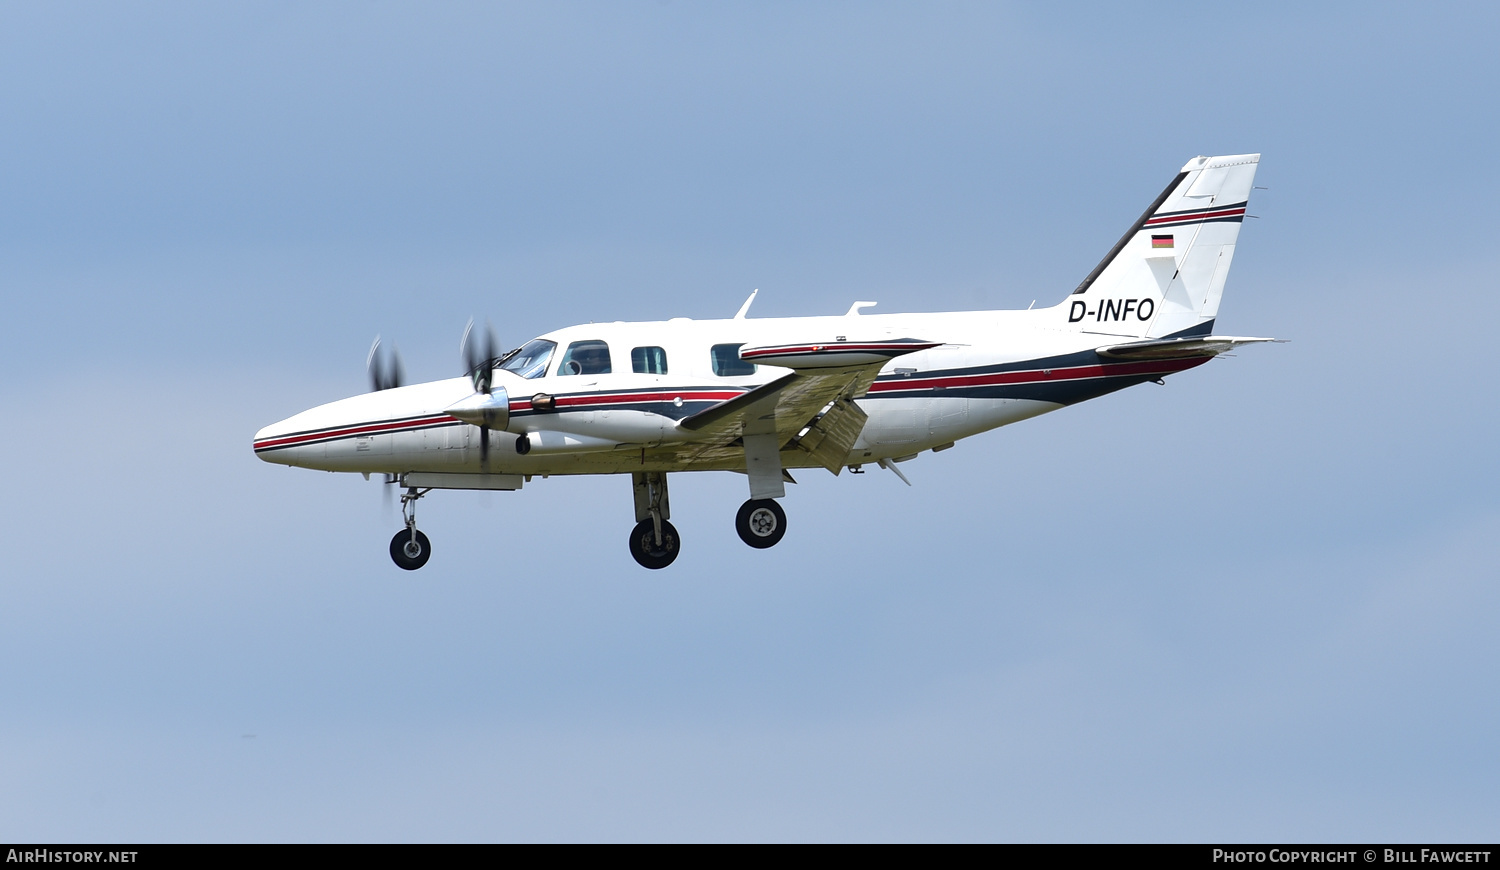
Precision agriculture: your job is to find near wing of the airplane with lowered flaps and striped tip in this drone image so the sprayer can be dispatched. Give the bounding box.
[651,339,938,474]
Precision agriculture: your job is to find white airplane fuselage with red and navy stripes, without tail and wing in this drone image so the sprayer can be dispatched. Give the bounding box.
[255,309,1206,476]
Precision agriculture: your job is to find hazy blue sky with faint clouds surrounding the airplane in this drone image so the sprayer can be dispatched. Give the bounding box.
[0,0,1500,842]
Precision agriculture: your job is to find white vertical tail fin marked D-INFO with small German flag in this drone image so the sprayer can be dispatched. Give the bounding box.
[1053,155,1260,338]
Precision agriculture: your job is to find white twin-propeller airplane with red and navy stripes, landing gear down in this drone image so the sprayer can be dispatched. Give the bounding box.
[254,155,1275,570]
